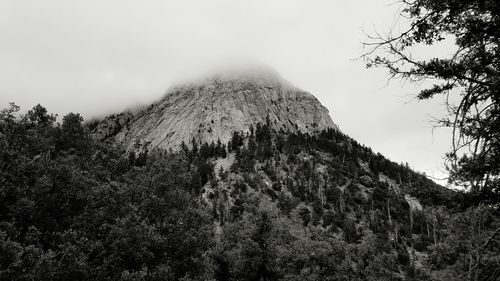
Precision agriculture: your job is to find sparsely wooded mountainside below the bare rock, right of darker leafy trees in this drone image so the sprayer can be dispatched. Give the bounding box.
[197,117,500,280]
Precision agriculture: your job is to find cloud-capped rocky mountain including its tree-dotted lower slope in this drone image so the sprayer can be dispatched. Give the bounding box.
[86,68,460,280]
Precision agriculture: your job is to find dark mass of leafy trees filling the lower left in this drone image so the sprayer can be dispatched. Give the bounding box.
[0,105,214,280]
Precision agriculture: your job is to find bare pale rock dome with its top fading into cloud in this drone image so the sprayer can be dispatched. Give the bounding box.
[93,67,338,150]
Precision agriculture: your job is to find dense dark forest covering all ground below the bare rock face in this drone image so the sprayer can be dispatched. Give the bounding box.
[0,104,500,280]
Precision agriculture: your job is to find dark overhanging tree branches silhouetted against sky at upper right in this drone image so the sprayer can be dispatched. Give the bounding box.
[364,0,500,203]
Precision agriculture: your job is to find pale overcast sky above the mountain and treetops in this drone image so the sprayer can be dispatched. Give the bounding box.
[0,0,450,183]
